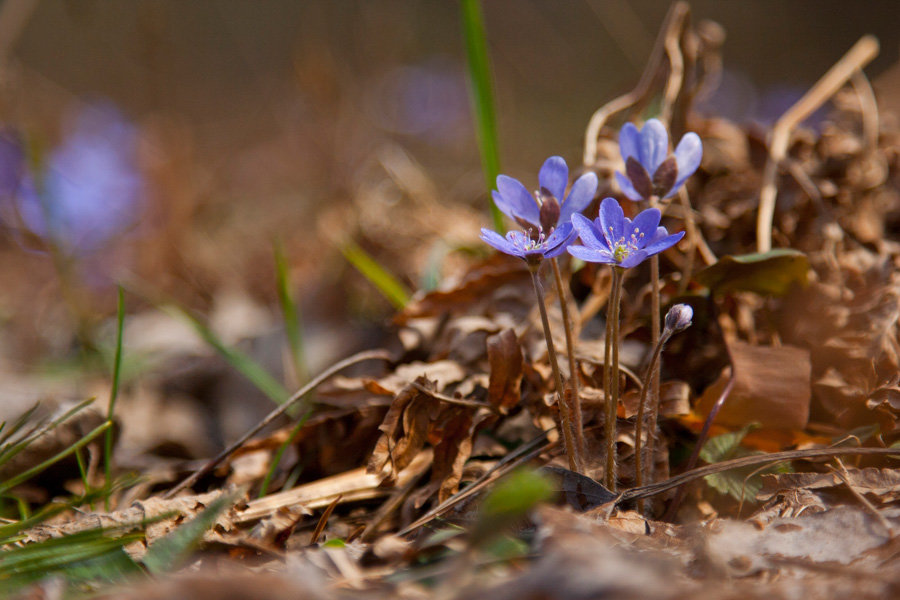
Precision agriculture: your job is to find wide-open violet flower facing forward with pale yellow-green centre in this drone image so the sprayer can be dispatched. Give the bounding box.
[568,198,684,269]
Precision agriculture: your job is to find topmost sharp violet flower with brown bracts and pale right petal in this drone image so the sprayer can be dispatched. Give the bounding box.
[616,119,703,200]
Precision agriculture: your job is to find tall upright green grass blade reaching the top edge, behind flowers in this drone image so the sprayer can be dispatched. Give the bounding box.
[460,0,504,232]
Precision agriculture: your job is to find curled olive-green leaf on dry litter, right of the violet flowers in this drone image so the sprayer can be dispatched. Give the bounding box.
[695,248,809,296]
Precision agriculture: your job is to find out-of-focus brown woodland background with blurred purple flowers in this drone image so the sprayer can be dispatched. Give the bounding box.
[0,0,900,380]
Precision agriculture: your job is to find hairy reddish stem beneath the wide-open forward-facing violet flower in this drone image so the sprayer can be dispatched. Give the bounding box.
[603,267,625,492]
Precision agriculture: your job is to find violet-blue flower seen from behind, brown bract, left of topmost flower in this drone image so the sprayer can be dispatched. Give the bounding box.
[492,156,597,233]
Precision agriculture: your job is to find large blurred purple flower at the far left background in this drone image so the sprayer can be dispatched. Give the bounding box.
[16,102,144,254]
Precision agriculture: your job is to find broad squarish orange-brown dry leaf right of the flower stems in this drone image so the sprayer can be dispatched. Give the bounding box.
[697,341,811,429]
